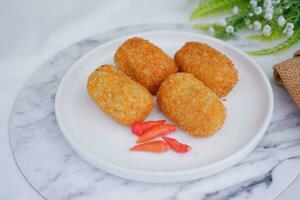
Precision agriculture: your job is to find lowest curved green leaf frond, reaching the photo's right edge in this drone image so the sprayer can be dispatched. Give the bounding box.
[248,29,300,55]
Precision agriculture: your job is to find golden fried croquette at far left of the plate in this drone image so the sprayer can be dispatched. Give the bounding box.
[87,65,154,126]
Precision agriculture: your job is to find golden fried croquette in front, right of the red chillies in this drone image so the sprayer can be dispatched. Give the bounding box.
[157,73,226,137]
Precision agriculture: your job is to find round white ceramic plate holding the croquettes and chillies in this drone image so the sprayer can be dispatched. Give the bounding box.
[55,31,273,182]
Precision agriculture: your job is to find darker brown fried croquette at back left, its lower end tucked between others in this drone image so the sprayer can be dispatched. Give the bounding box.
[114,37,177,94]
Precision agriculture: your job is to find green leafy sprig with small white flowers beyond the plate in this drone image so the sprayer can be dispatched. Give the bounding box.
[191,0,300,55]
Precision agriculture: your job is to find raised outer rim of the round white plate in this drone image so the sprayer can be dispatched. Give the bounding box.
[55,30,274,183]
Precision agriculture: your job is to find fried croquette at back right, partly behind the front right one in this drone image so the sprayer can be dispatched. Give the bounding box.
[174,42,238,97]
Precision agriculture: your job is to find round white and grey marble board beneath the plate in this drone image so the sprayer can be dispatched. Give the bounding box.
[10,24,300,200]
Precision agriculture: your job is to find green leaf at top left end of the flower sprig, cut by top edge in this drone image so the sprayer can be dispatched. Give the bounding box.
[190,0,248,20]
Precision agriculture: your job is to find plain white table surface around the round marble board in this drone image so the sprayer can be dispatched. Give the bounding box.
[0,0,300,200]
